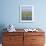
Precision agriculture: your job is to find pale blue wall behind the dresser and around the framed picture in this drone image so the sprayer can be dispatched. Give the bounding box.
[0,0,46,43]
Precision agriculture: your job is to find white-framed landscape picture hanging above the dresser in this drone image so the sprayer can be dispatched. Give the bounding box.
[20,5,34,22]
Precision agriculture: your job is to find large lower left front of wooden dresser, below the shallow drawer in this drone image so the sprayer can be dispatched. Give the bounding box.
[3,34,23,46]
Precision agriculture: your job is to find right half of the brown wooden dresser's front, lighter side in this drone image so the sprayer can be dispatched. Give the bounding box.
[24,32,44,46]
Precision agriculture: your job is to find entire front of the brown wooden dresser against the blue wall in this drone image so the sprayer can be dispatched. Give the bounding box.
[2,32,45,46]
